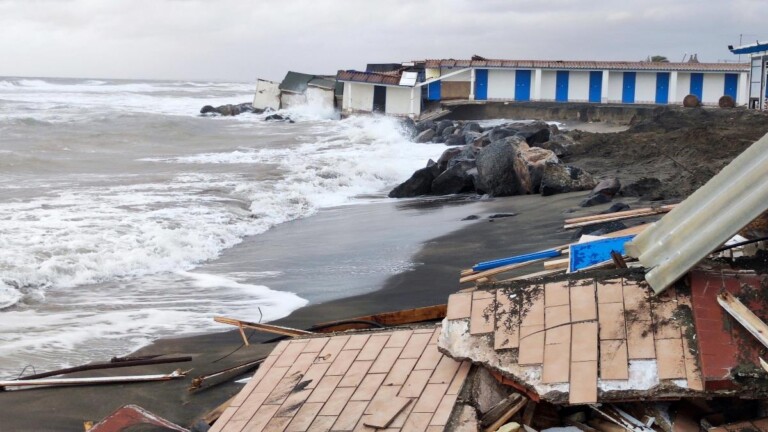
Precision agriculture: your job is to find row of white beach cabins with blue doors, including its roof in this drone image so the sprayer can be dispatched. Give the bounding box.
[336,58,750,118]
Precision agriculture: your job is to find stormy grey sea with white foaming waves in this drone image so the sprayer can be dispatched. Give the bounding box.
[0,77,442,378]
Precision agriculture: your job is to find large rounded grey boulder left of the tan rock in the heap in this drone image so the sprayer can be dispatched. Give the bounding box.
[475,140,531,196]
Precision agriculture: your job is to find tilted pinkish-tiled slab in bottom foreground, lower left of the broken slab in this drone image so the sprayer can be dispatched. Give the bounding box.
[211,328,472,432]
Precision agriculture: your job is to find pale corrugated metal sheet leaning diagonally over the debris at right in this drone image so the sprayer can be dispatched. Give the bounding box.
[626,135,768,293]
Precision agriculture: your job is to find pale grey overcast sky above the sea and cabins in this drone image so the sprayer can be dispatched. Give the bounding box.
[0,0,768,81]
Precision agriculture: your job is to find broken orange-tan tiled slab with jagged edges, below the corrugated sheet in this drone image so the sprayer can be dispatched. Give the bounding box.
[447,277,703,404]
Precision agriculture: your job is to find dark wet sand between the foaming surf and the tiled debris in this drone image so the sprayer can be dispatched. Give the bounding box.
[0,192,636,431]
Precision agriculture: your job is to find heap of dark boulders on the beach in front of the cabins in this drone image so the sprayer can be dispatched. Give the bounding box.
[389,120,597,198]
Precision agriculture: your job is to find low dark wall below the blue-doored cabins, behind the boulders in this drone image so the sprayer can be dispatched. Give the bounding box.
[444,102,668,125]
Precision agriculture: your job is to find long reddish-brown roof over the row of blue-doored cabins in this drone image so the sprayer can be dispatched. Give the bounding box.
[426,59,749,72]
